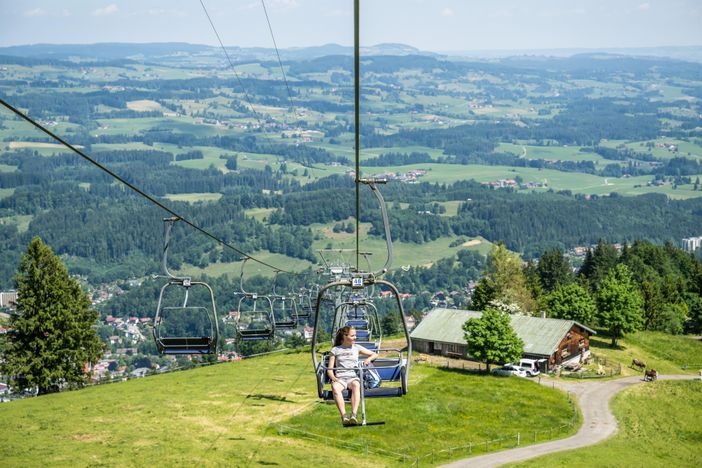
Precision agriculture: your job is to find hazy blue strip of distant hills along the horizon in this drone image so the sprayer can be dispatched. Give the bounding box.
[0,42,702,62]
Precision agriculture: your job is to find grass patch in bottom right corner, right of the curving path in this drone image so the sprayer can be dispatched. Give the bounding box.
[510,380,702,468]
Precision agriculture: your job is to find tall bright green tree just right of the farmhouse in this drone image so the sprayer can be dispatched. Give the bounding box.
[595,264,643,347]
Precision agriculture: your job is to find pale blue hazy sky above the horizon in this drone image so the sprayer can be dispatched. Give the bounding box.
[0,0,702,51]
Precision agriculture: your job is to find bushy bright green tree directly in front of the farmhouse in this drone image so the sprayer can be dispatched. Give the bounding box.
[463,309,524,371]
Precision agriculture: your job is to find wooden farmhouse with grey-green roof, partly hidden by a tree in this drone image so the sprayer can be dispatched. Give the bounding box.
[410,308,595,369]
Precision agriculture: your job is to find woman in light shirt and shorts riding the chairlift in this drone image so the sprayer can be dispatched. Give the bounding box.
[327,326,378,426]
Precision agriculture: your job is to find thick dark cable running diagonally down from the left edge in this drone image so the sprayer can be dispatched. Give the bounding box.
[0,98,293,273]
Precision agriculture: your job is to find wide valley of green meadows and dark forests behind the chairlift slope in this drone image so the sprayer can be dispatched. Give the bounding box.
[0,48,702,290]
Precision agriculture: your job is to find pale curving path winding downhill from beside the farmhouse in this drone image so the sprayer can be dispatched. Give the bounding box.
[444,375,699,468]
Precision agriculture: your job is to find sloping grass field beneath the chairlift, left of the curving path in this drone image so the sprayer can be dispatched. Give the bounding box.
[0,352,573,467]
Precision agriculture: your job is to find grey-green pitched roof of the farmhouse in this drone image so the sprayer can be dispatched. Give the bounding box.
[410,309,595,356]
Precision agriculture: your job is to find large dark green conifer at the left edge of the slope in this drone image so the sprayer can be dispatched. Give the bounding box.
[0,237,104,395]
